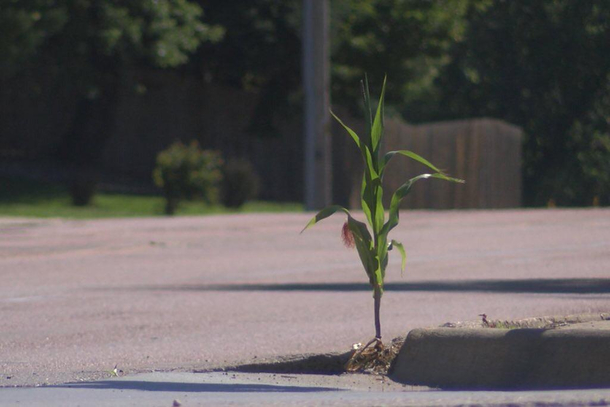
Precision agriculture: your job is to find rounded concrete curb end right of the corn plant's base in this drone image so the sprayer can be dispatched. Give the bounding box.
[390,328,610,389]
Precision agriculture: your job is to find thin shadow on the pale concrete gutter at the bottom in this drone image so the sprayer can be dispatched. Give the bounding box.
[57,380,341,393]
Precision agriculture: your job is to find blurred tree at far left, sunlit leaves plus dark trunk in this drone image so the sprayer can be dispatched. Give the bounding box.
[0,0,223,198]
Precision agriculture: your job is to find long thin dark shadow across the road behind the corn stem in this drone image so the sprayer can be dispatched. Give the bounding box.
[115,278,610,294]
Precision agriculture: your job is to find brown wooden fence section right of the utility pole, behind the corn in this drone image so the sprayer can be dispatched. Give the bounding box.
[333,115,522,209]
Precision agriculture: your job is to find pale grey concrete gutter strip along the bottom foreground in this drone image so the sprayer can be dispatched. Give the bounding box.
[0,373,610,407]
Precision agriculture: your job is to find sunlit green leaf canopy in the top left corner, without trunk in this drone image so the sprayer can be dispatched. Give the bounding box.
[0,0,224,80]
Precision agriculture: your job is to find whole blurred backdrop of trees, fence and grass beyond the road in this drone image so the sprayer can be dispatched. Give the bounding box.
[0,0,610,217]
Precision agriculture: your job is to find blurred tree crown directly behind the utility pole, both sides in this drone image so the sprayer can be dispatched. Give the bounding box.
[192,0,473,136]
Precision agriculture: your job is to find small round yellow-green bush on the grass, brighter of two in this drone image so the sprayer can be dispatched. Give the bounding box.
[153,142,222,215]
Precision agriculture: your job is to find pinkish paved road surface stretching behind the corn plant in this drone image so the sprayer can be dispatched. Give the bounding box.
[0,209,610,386]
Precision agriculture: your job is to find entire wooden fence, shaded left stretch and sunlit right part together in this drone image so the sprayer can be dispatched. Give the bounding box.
[0,71,521,209]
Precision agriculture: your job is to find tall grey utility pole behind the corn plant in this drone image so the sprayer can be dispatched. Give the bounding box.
[303,0,332,210]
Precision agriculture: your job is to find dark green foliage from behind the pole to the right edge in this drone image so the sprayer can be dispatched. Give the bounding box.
[198,0,610,205]
